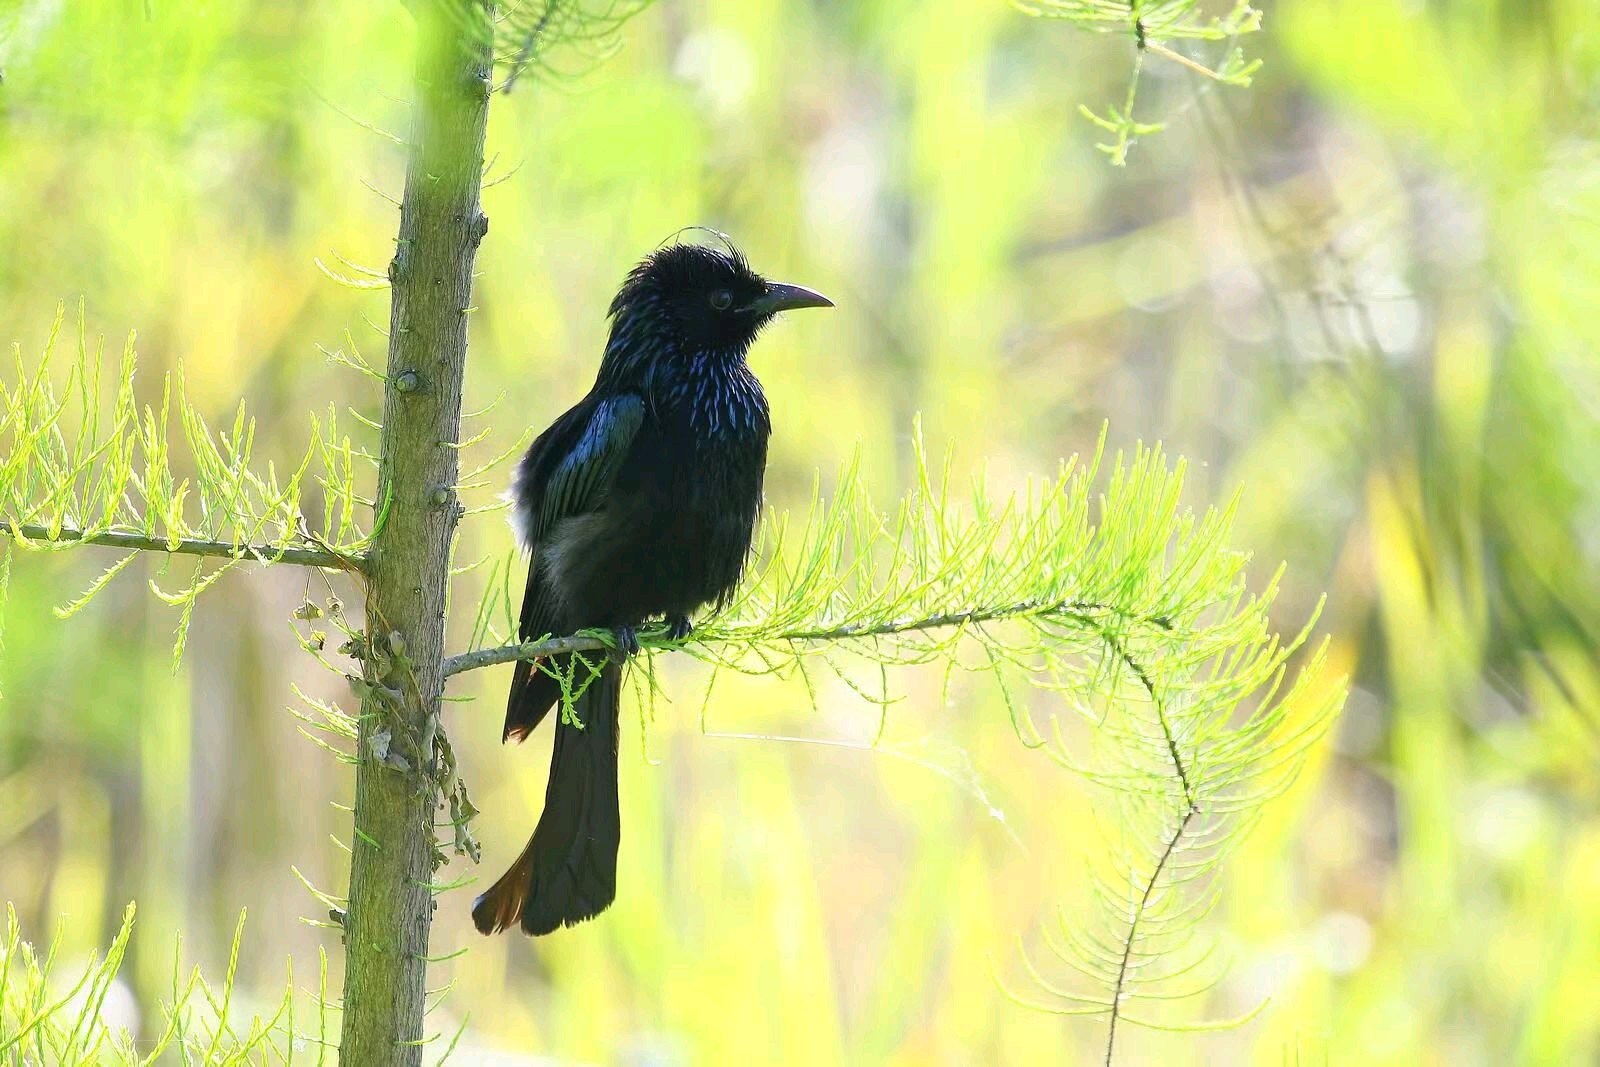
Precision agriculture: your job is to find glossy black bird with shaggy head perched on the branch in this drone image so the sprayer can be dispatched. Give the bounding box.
[472,245,832,936]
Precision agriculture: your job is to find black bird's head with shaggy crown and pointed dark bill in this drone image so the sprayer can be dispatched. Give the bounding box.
[611,245,834,358]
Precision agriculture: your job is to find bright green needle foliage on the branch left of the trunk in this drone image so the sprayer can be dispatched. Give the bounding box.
[0,309,371,664]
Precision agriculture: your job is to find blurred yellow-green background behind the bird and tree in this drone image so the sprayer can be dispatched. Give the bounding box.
[0,0,1600,1067]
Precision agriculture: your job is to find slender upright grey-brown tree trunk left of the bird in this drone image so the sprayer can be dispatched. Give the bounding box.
[341,0,493,1067]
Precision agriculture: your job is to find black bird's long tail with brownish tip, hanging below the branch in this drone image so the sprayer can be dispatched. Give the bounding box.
[472,659,622,936]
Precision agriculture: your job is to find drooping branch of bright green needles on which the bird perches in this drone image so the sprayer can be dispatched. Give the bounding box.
[446,434,1342,1061]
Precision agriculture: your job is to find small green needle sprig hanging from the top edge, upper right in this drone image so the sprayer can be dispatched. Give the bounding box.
[1013,0,1261,166]
